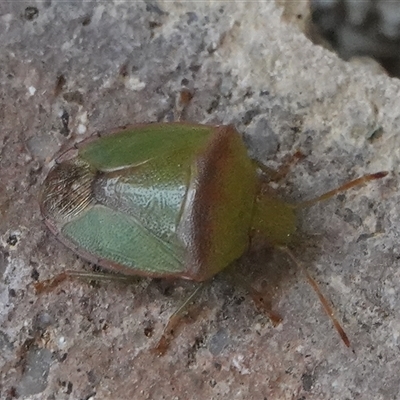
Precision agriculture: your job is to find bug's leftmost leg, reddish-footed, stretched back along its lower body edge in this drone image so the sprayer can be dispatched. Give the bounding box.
[34,270,140,294]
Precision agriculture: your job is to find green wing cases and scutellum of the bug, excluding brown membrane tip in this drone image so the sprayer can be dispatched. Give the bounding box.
[62,124,213,275]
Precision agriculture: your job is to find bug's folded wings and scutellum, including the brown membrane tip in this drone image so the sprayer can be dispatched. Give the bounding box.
[41,124,216,276]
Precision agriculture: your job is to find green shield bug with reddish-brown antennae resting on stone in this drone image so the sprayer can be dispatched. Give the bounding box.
[40,123,387,354]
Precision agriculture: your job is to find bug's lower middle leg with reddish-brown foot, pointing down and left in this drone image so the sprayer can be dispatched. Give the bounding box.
[152,282,207,356]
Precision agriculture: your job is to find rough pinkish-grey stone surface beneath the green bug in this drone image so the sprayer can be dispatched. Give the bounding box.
[0,0,400,400]
